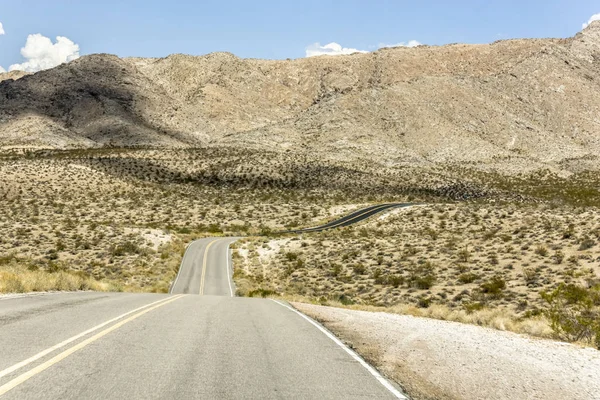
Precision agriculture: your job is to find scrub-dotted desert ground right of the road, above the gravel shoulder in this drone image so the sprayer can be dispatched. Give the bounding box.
[236,203,600,342]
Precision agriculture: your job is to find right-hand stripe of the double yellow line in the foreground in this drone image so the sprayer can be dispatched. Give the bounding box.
[0,294,185,396]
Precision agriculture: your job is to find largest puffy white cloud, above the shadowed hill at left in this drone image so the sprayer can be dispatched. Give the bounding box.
[8,33,79,72]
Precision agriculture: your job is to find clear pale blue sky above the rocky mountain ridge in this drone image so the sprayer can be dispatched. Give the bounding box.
[0,0,600,68]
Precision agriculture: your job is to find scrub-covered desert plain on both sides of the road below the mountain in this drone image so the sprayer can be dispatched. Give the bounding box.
[0,149,600,350]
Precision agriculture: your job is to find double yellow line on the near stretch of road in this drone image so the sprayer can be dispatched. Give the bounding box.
[0,294,185,396]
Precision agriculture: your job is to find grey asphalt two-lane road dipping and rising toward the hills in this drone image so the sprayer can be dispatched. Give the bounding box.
[0,205,405,400]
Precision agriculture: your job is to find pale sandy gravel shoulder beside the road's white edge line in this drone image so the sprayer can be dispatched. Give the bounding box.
[292,303,600,399]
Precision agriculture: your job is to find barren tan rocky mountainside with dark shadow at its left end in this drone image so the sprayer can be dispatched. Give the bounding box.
[0,22,600,171]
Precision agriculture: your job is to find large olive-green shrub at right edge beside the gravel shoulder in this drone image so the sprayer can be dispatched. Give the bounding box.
[541,283,600,349]
